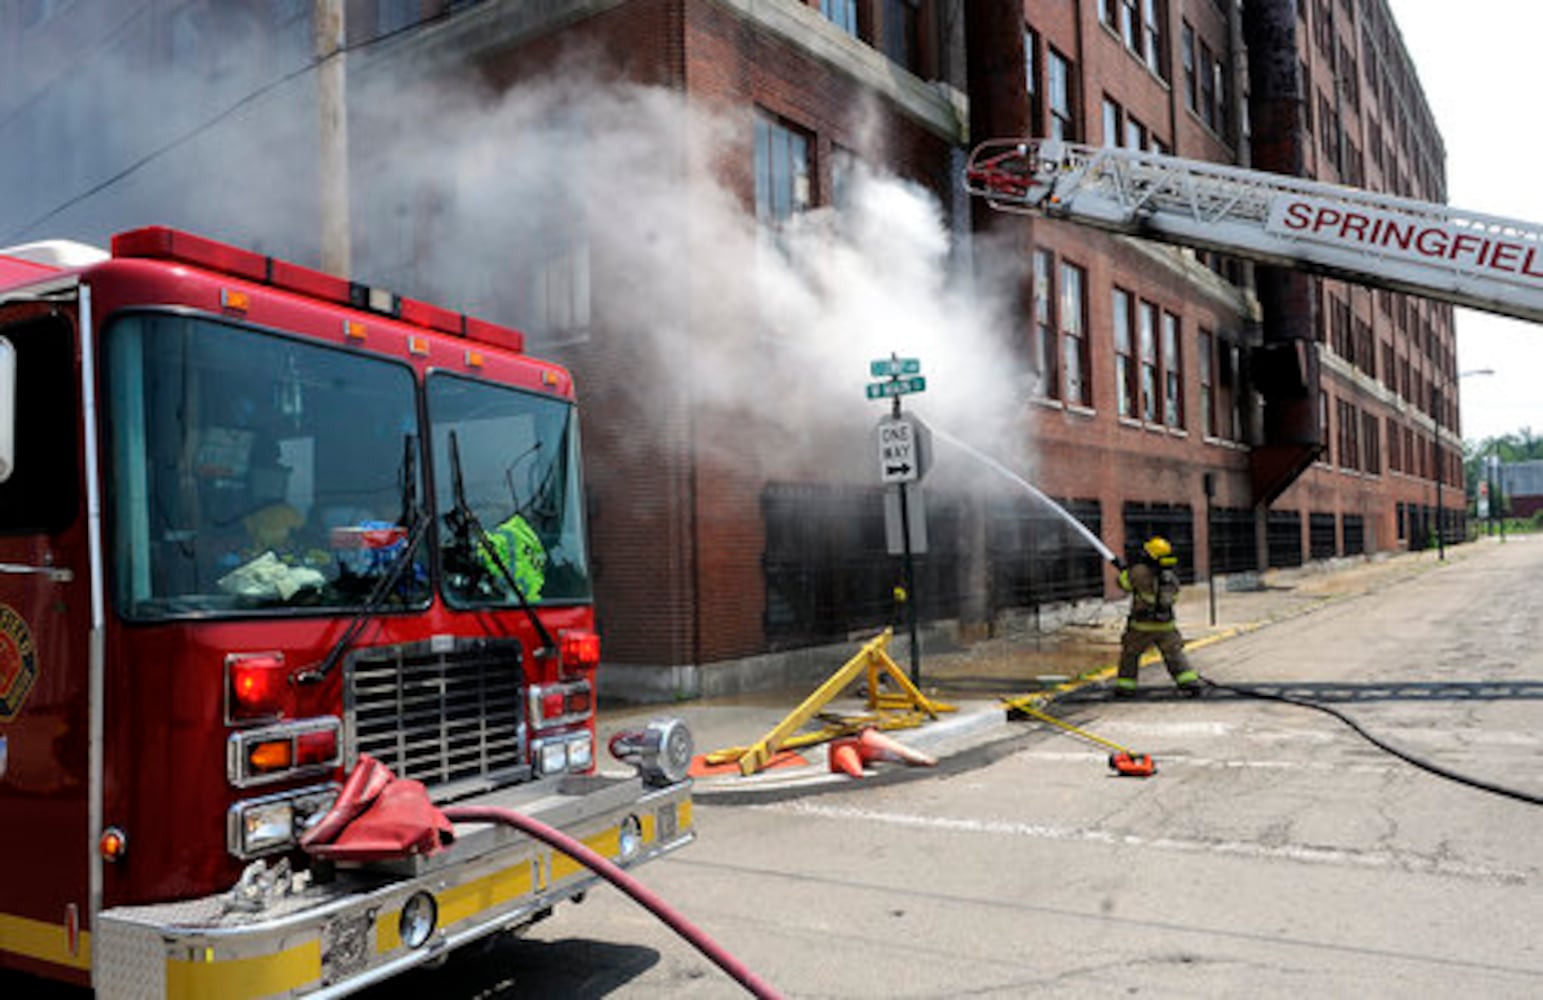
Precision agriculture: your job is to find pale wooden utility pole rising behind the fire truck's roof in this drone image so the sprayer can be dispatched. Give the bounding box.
[312,0,352,278]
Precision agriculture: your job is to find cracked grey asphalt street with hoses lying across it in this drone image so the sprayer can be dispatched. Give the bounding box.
[395,539,1543,997]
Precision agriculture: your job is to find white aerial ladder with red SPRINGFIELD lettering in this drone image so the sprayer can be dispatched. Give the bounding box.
[964,139,1543,321]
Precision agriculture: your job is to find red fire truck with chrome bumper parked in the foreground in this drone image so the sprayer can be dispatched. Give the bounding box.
[0,227,694,997]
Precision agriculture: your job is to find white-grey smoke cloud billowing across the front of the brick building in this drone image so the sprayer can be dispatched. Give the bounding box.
[5,37,1028,478]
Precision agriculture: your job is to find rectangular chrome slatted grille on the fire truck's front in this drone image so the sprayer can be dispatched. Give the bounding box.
[346,639,531,801]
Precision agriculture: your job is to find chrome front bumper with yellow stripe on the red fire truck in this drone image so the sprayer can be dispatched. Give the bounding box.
[91,776,696,1000]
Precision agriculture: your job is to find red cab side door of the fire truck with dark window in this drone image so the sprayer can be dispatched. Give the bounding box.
[0,296,94,974]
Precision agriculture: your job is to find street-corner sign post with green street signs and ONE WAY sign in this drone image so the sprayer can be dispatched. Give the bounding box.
[867,355,932,685]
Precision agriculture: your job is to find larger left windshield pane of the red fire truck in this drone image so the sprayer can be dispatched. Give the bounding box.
[105,313,429,619]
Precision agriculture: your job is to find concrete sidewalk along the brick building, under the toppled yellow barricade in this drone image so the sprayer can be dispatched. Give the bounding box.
[597,540,1456,802]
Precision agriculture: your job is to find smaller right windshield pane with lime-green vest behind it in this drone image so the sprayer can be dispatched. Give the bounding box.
[427,373,589,606]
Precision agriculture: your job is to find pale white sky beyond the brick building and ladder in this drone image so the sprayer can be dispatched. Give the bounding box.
[1389,0,1543,443]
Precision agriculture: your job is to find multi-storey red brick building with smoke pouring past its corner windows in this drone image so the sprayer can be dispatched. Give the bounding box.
[0,0,1463,696]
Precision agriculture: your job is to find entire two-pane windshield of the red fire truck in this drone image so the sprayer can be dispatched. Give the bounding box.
[105,312,589,620]
